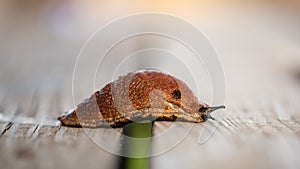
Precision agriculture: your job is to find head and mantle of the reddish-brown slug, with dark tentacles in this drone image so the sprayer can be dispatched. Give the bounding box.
[130,71,224,122]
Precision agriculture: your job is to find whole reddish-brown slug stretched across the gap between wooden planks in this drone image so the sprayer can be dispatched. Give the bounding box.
[58,70,225,127]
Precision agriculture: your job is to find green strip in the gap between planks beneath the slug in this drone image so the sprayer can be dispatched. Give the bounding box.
[123,122,152,169]
